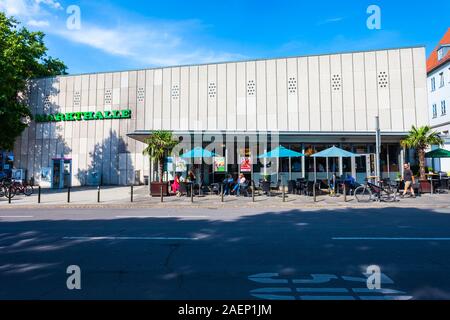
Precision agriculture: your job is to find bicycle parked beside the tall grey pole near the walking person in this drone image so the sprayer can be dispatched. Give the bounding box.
[354,179,399,202]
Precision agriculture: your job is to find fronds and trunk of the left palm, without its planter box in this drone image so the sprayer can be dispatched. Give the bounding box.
[142,130,179,182]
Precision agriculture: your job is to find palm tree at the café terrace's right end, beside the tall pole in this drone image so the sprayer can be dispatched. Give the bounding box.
[400,126,444,180]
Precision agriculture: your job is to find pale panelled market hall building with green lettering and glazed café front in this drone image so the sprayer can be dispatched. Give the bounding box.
[14,47,429,187]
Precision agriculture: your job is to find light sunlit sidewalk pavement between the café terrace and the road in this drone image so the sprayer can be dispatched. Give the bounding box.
[0,186,450,210]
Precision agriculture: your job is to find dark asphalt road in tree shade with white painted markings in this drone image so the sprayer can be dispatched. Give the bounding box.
[0,208,450,299]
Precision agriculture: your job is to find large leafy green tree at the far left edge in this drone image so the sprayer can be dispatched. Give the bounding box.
[0,12,67,150]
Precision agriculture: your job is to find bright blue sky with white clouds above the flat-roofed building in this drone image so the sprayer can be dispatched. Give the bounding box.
[0,0,450,73]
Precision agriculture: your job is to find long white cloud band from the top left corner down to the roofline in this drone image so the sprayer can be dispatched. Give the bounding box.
[0,0,245,66]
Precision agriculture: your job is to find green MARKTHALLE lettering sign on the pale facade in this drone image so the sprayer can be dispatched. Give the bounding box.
[34,110,131,122]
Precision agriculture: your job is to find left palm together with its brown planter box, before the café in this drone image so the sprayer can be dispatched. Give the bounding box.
[142,130,178,196]
